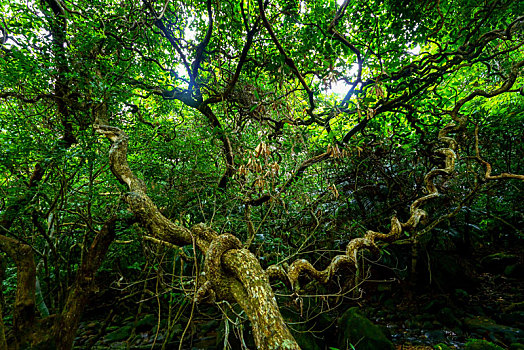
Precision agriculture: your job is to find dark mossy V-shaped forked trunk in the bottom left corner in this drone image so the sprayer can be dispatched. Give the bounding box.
[0,218,116,350]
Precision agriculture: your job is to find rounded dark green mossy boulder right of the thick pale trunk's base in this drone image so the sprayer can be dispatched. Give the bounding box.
[338,307,395,350]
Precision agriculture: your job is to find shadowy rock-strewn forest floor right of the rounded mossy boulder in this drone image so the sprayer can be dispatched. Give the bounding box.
[365,246,524,349]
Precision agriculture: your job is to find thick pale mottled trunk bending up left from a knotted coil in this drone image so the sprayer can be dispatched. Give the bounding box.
[95,125,299,350]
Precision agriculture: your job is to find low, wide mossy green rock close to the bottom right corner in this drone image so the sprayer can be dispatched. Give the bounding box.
[464,316,524,343]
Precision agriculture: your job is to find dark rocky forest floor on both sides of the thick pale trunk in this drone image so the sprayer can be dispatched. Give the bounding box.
[75,243,524,350]
